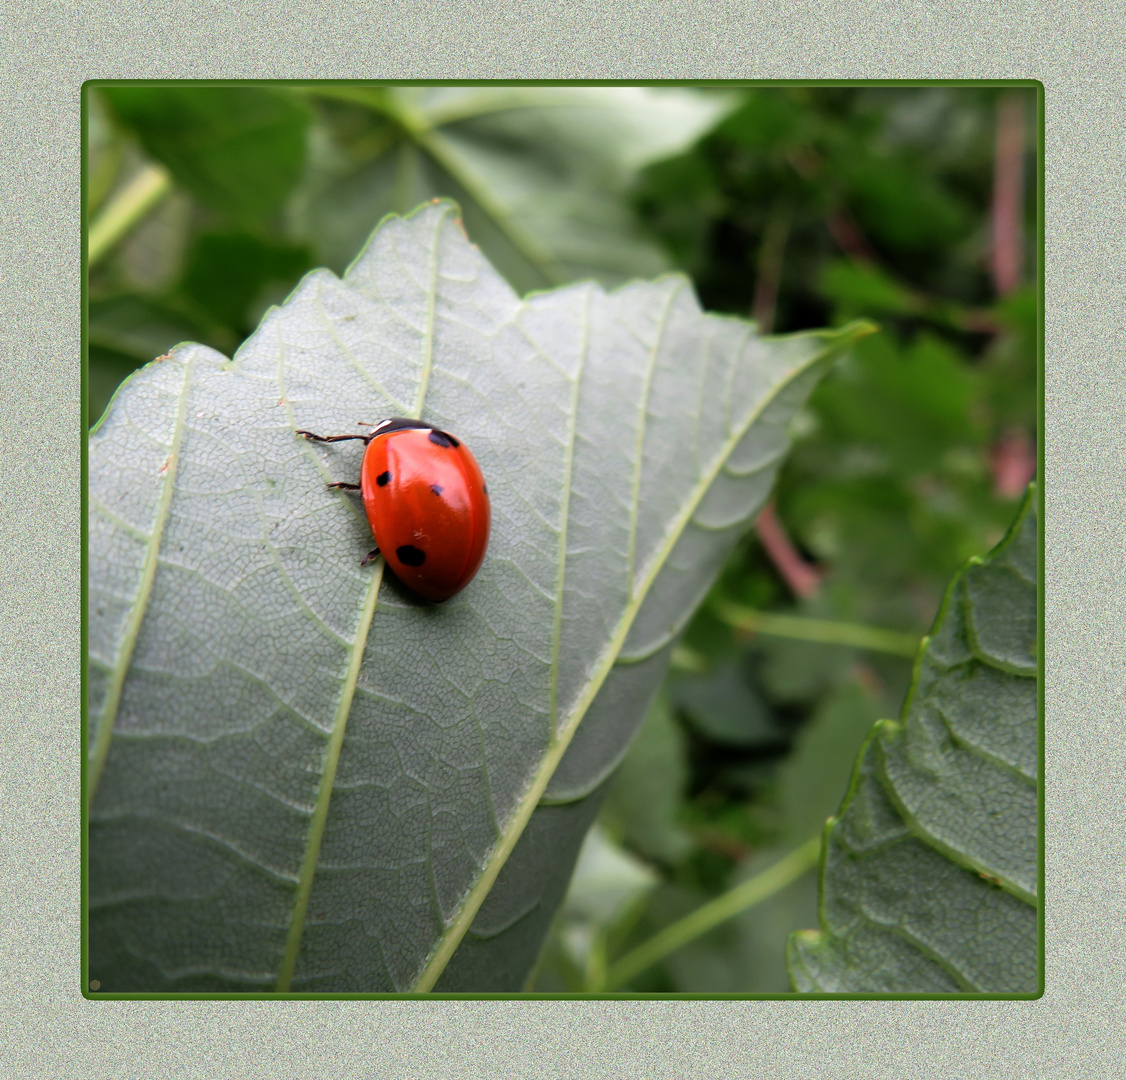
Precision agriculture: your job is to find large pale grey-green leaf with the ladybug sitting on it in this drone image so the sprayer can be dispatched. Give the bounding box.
[88,204,867,992]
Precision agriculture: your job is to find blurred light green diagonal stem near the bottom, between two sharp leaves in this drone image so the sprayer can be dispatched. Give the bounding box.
[601,833,821,990]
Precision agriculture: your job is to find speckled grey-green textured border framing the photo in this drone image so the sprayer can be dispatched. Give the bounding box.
[0,2,1126,1080]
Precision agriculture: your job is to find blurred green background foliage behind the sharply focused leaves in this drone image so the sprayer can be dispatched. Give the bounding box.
[86,83,1039,993]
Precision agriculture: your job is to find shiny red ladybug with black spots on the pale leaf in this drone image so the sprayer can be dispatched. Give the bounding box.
[297,417,490,604]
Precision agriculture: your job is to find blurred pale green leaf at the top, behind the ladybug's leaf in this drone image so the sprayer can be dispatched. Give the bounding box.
[286,83,735,292]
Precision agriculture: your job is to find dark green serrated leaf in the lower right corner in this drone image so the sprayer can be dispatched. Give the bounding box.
[787,489,1039,993]
